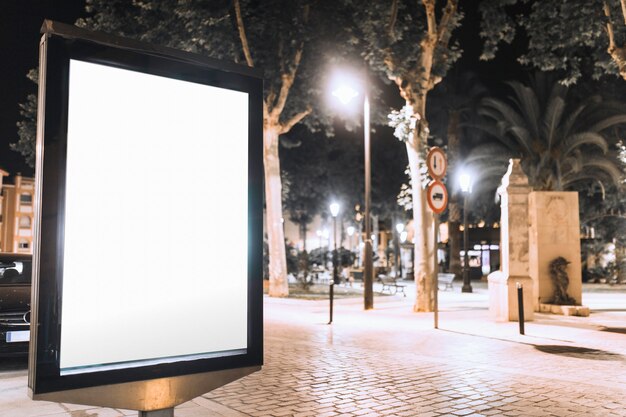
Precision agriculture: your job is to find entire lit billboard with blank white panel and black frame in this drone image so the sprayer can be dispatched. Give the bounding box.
[28,21,263,417]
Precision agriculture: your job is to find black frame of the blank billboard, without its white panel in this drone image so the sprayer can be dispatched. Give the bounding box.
[28,20,263,411]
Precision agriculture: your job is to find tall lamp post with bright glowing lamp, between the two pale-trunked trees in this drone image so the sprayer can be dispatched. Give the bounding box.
[332,76,374,310]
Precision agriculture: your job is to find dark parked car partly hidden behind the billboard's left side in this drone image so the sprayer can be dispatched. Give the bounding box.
[0,253,32,356]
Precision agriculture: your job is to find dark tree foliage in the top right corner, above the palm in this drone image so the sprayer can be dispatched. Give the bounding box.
[480,0,626,84]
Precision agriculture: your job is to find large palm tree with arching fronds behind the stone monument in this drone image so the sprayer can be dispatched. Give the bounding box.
[468,74,626,191]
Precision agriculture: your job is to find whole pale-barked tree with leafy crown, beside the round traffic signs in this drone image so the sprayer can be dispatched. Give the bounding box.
[353,0,462,311]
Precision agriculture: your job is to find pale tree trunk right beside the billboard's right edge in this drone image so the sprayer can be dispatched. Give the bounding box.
[263,126,289,297]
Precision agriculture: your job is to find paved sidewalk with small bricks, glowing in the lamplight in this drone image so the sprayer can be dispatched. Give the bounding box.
[0,288,626,417]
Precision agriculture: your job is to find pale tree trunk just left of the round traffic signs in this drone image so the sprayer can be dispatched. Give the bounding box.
[406,132,435,312]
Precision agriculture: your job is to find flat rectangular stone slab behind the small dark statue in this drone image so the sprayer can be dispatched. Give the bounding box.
[528,191,582,311]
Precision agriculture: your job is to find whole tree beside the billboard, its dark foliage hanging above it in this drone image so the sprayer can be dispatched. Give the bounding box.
[17,0,349,297]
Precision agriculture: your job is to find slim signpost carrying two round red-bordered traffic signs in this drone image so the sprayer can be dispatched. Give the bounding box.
[426,146,448,329]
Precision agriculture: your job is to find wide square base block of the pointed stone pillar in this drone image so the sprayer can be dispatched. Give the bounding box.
[487,271,534,321]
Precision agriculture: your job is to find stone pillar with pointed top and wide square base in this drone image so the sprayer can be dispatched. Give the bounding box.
[488,159,534,321]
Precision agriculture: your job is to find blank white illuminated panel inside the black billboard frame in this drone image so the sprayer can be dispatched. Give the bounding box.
[60,60,249,374]
